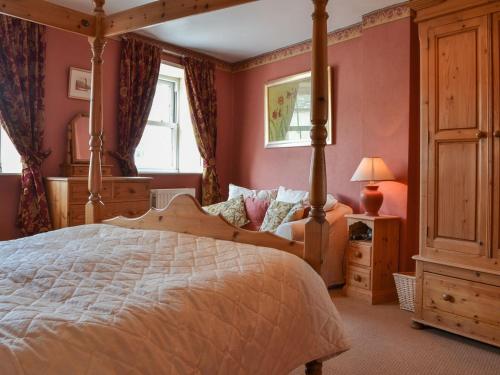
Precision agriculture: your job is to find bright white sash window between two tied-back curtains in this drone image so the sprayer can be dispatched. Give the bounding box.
[135,64,203,173]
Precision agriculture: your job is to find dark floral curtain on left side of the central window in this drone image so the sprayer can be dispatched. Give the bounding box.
[112,38,162,176]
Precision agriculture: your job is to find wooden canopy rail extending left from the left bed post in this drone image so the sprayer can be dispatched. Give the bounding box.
[0,0,95,36]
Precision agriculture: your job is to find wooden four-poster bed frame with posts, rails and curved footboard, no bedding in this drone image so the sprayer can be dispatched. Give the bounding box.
[0,0,344,374]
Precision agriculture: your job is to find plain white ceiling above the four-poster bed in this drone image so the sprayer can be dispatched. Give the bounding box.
[50,0,401,62]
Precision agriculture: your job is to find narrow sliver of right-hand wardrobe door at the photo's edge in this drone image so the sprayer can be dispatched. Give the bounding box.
[491,13,500,259]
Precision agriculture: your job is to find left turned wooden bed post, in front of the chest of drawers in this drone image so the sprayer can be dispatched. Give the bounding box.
[85,0,106,224]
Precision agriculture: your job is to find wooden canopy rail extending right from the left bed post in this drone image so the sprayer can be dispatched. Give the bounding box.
[102,0,256,37]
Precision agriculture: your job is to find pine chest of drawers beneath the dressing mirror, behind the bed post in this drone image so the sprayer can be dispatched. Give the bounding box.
[45,177,152,229]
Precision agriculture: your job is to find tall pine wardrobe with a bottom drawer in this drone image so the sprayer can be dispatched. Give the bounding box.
[410,0,500,346]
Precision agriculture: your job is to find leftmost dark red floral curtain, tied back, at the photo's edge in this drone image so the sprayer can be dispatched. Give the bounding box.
[0,15,51,235]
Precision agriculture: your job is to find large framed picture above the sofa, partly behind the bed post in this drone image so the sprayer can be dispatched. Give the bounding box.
[264,67,332,148]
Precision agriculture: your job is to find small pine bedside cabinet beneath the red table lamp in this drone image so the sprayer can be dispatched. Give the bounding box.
[344,215,399,304]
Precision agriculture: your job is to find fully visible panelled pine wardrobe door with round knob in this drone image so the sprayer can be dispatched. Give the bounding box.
[424,16,490,261]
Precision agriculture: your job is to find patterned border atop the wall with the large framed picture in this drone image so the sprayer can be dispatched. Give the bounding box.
[232,2,412,72]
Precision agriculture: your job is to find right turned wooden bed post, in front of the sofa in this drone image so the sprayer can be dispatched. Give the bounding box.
[304,0,329,280]
